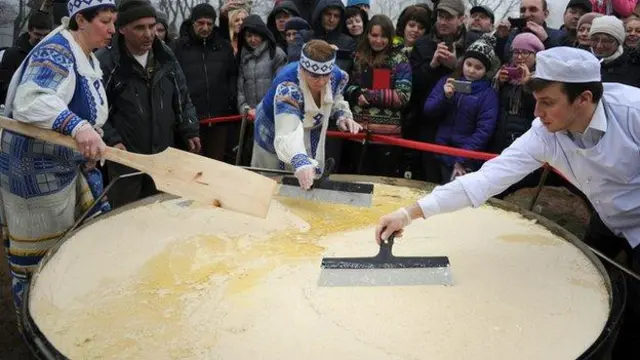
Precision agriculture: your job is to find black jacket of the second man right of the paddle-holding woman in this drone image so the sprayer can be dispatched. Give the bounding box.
[173,20,238,120]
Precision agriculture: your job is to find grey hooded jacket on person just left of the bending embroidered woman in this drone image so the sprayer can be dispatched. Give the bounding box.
[238,15,287,112]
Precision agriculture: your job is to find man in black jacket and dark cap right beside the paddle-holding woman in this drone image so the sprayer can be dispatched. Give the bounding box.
[97,0,200,207]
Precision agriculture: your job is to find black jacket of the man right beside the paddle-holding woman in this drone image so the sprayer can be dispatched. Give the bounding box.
[96,35,198,154]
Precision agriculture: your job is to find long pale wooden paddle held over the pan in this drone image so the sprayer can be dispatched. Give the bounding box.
[0,116,277,218]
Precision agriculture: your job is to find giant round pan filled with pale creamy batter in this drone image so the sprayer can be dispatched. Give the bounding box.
[23,176,626,360]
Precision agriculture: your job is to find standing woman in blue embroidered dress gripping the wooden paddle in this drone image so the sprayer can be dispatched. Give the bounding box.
[0,0,115,320]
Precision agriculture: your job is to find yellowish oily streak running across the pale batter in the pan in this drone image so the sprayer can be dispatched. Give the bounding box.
[45,189,422,358]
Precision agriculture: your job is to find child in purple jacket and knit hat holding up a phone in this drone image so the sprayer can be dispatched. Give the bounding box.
[424,35,499,183]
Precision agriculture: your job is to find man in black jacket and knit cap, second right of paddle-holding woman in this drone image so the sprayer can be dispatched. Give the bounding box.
[174,4,238,160]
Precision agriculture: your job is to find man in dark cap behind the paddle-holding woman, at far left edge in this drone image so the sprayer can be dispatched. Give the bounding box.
[0,11,52,104]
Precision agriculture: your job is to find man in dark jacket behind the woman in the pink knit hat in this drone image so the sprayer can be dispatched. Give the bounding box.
[496,0,565,63]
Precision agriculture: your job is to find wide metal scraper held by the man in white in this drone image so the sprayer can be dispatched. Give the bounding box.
[318,234,453,286]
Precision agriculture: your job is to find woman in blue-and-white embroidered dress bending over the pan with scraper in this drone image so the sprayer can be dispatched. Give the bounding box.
[251,40,362,189]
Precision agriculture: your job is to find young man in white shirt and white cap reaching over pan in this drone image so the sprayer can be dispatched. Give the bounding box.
[376,47,640,356]
